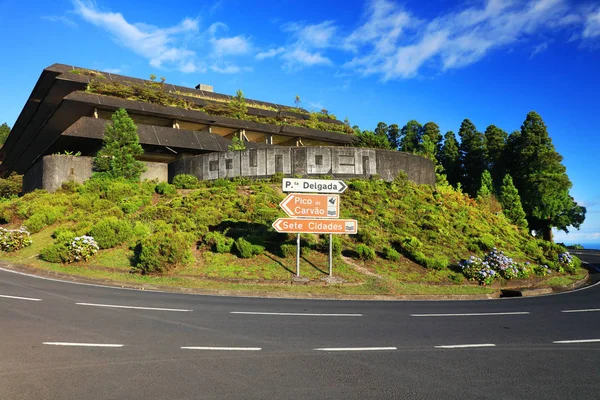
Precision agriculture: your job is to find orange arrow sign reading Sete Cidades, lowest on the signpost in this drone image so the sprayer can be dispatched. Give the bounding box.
[273,218,358,235]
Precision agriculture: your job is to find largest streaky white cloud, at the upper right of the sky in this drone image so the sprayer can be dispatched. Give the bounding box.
[344,0,600,80]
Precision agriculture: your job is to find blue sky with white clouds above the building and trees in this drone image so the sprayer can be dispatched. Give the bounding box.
[0,0,600,244]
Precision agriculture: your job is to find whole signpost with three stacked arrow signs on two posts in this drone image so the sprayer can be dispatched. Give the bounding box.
[273,178,358,277]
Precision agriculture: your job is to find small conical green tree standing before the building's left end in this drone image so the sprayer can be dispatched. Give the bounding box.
[94,108,145,180]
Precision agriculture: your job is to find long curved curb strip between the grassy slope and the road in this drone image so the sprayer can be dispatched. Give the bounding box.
[0,260,589,301]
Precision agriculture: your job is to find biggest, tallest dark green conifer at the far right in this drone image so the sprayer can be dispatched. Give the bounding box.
[505,111,586,241]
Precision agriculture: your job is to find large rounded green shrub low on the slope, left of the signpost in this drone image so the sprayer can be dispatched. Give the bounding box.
[136,232,193,273]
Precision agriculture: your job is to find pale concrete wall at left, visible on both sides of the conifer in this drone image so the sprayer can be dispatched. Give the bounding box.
[23,155,169,193]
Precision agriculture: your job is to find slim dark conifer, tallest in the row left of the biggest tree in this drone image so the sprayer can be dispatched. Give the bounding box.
[458,119,485,197]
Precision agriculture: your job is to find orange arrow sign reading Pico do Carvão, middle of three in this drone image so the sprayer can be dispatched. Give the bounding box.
[279,193,340,218]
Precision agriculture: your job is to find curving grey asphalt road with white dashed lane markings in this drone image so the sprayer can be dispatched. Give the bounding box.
[0,251,600,400]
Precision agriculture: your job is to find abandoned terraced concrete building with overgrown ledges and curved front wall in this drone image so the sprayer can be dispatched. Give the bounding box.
[0,64,435,190]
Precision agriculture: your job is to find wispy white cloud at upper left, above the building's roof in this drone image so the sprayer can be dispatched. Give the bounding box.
[73,0,198,70]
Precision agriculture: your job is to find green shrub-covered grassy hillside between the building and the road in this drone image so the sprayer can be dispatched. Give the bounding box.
[0,176,581,294]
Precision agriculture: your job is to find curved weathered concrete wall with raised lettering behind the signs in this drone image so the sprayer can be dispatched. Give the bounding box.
[169,146,435,186]
